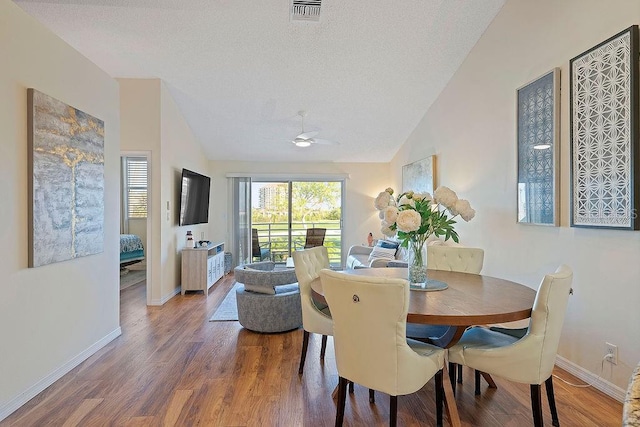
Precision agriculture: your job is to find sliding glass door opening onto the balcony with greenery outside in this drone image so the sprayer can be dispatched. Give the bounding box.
[251,180,343,266]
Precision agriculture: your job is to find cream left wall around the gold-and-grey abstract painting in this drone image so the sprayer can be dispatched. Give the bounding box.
[0,1,120,419]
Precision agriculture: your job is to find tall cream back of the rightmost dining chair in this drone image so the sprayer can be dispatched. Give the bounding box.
[524,265,573,381]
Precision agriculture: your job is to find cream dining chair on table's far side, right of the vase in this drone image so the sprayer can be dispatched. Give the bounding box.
[407,245,484,390]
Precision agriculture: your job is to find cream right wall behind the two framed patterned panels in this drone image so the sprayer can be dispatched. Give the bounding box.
[392,0,640,398]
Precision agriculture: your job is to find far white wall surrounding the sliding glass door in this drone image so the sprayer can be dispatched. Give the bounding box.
[209,161,390,262]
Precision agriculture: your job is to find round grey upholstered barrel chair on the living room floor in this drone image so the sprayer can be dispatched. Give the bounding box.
[234,261,302,333]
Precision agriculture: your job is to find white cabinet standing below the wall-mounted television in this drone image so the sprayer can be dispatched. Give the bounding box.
[181,242,224,295]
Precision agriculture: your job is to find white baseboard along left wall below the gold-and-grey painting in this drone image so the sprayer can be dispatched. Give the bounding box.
[0,326,122,421]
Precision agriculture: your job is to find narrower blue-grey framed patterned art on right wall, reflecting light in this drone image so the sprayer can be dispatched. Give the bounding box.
[516,68,560,225]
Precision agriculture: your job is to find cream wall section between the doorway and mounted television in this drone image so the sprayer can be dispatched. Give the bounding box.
[118,79,208,305]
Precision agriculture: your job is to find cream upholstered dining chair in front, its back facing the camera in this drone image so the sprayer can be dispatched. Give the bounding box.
[320,269,444,426]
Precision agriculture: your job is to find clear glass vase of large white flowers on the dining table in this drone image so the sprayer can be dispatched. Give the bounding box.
[375,187,476,288]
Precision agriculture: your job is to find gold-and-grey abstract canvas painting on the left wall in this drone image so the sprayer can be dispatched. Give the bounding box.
[27,89,104,267]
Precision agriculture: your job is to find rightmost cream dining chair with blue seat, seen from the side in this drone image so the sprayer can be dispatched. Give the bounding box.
[449,265,573,426]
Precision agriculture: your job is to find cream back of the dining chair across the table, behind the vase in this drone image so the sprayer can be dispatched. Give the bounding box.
[427,245,484,274]
